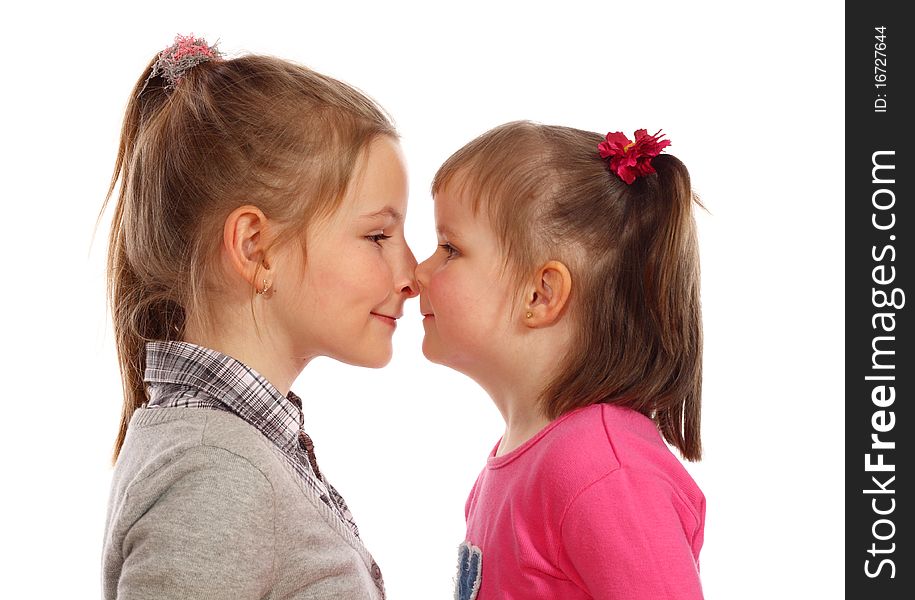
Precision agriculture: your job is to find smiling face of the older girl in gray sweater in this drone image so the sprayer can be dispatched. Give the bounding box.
[268,136,416,367]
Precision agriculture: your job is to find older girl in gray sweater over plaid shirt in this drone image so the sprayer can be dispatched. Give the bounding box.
[103,36,416,600]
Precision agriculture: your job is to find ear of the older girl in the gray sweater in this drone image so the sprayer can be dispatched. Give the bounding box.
[222,205,272,289]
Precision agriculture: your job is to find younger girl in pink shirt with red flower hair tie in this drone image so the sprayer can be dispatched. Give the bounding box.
[416,122,705,600]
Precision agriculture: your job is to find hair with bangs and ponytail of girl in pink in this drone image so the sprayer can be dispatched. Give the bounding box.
[432,121,702,460]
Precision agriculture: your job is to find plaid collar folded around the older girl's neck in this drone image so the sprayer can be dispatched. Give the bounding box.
[143,341,303,455]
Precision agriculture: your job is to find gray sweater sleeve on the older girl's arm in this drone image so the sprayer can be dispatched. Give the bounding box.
[117,448,275,600]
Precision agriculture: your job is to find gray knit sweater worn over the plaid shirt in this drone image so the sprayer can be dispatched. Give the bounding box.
[102,408,384,600]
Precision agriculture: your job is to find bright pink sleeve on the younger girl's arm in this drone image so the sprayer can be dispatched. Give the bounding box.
[559,469,704,600]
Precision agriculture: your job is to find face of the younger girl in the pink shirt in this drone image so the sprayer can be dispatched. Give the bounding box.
[416,184,514,383]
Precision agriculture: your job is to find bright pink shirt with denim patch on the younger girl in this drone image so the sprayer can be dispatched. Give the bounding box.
[457,404,705,600]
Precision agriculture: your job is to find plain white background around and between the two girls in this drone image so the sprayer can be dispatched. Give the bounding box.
[0,0,844,599]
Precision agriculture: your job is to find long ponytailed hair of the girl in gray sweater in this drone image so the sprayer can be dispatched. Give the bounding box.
[100,50,397,458]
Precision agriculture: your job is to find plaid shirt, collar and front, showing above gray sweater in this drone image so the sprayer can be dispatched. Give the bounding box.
[144,341,362,540]
